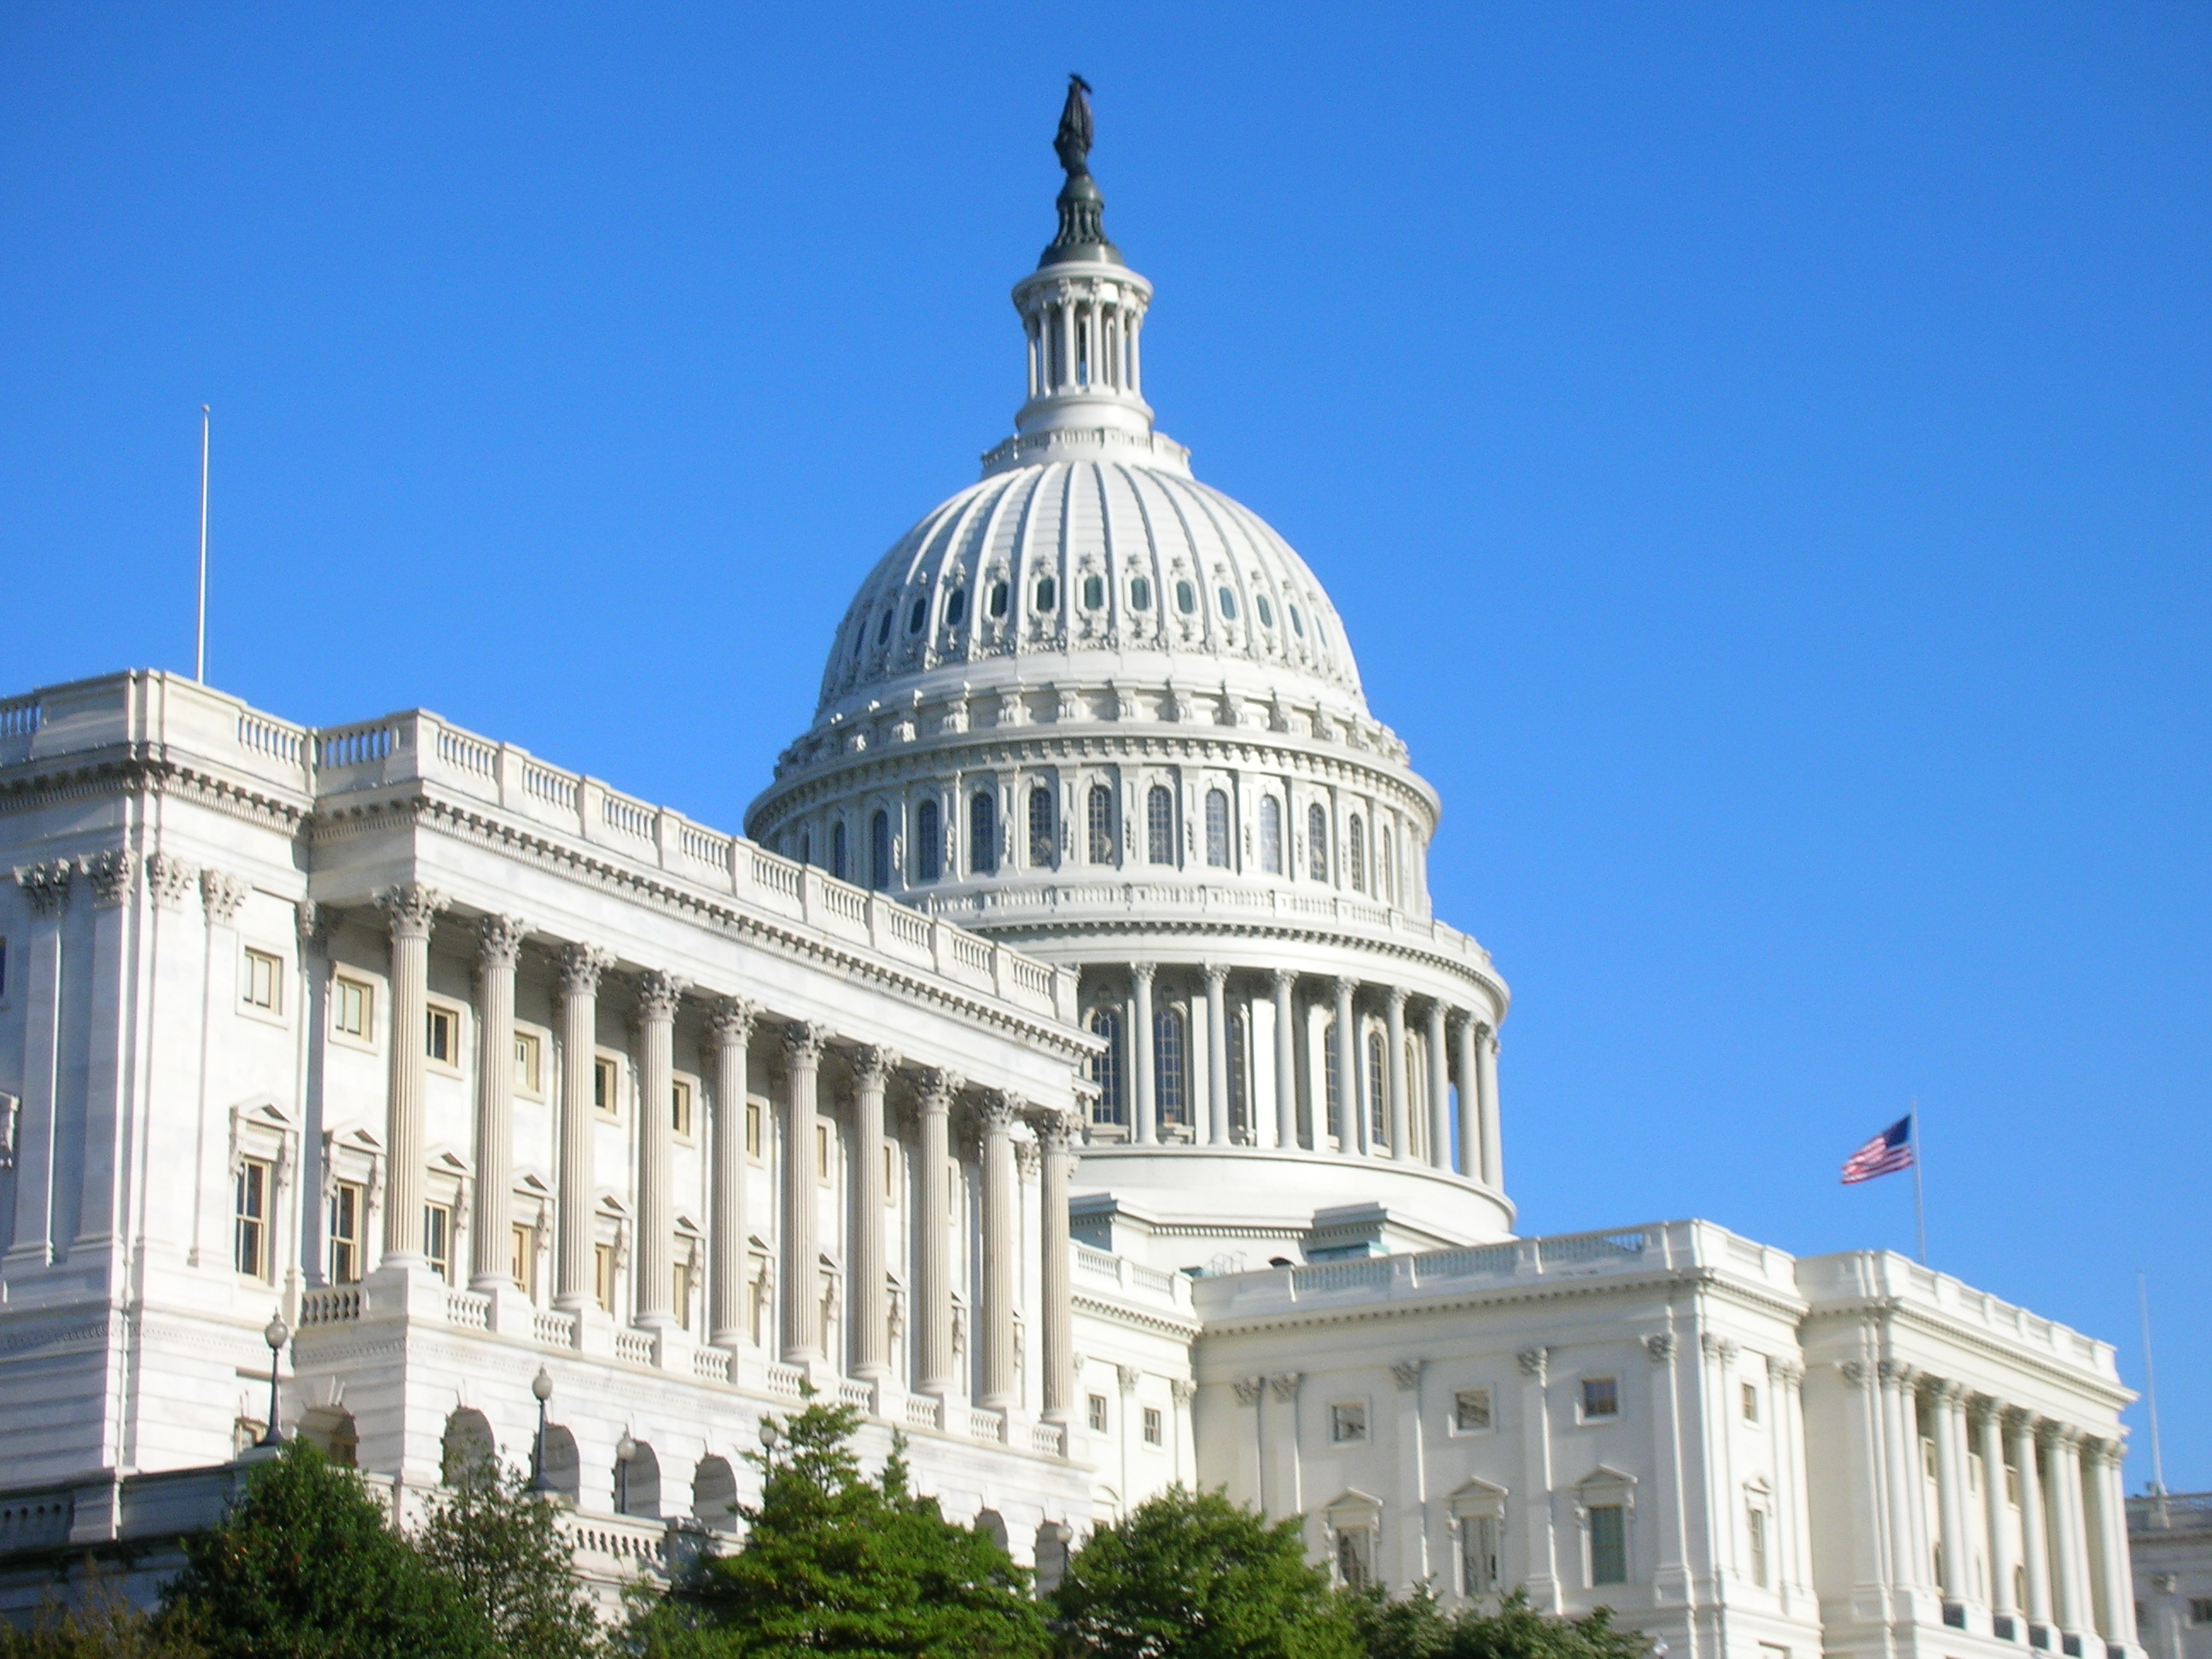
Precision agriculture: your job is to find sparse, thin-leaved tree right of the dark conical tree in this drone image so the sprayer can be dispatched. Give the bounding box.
[414,1458,606,1659]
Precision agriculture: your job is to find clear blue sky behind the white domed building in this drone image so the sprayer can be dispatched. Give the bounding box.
[0,4,2212,1488]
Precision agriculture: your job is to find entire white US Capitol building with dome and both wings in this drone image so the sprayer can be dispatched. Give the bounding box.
[0,84,2141,1659]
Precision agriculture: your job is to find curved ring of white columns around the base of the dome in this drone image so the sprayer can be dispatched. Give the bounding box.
[1088,963,1505,1188]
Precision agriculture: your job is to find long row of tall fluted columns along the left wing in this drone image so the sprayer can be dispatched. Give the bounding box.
[364,885,1080,1423]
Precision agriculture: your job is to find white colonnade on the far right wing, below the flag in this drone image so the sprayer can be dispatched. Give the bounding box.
[1876,1360,2134,1659]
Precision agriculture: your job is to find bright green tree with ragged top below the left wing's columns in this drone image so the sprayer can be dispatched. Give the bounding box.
[632,1405,1051,1659]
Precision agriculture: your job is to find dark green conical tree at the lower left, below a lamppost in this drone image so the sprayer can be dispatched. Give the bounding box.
[161,1440,498,1659]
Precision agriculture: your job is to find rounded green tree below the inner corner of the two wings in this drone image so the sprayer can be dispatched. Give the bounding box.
[1053,1487,1358,1659]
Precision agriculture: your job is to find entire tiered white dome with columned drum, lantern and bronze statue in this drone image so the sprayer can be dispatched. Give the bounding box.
[746,84,1513,1270]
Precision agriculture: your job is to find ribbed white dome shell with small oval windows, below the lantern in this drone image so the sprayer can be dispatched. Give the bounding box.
[821,449,1365,714]
